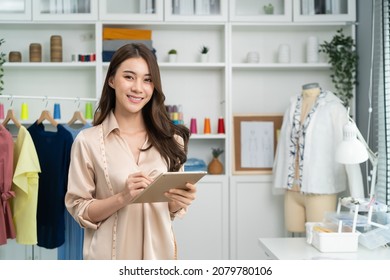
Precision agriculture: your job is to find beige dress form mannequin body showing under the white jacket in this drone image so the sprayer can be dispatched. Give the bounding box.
[284,83,337,233]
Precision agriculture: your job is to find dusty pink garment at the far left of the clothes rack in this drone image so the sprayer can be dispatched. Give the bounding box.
[0,124,16,245]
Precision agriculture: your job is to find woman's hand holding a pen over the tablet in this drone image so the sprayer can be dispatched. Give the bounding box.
[122,172,153,204]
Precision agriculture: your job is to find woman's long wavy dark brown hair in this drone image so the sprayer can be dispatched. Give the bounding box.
[94,43,190,171]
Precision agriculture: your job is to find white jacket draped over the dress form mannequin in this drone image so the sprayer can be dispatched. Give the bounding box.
[273,91,364,198]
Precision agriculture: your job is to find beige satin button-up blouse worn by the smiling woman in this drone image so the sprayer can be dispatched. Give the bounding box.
[65,110,186,260]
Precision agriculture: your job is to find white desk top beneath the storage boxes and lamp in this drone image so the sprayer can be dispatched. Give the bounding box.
[259,238,390,260]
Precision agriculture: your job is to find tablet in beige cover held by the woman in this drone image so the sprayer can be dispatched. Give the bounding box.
[131,171,207,203]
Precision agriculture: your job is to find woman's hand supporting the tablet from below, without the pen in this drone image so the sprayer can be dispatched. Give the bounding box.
[165,183,196,213]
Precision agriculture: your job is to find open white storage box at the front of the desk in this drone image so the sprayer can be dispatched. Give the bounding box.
[306,223,360,253]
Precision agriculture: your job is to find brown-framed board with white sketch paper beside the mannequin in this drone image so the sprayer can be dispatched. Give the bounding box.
[233,115,283,174]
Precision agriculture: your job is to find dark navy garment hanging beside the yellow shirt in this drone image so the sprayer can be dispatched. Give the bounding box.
[27,122,73,249]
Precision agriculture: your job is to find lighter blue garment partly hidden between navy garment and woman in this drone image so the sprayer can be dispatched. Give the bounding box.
[57,123,92,260]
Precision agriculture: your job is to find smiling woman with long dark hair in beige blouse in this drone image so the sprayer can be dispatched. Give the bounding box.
[65,44,196,259]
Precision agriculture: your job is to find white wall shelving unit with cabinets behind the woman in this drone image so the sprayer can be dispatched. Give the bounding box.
[0,0,356,259]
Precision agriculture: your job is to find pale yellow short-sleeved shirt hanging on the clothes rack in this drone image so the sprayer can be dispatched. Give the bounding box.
[11,126,41,245]
